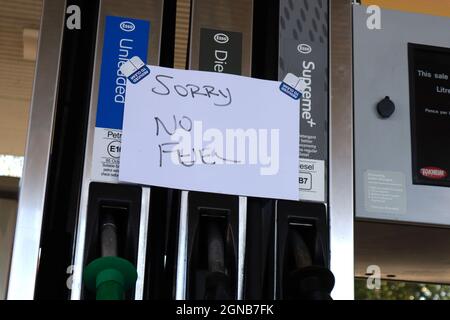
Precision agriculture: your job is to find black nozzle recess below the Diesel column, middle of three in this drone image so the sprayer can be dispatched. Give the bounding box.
[186,193,239,300]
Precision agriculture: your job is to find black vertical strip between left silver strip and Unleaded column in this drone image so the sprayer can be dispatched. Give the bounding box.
[35,0,98,299]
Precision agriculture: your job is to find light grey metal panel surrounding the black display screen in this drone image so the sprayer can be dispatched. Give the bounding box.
[354,6,450,225]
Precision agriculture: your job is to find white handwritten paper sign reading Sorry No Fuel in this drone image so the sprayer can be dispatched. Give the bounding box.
[119,66,299,200]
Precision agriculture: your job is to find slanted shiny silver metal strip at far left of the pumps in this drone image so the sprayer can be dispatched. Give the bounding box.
[8,0,65,299]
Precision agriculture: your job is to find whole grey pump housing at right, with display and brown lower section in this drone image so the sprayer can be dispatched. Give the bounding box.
[352,0,450,283]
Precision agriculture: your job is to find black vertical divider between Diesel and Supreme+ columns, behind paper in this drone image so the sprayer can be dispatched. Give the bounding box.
[243,0,279,300]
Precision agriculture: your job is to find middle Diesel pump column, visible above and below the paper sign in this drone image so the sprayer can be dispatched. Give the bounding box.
[176,0,253,299]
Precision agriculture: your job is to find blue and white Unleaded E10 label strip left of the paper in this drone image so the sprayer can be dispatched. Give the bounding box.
[91,16,150,182]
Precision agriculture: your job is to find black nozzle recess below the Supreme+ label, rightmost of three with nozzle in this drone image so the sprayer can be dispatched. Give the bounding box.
[275,201,334,300]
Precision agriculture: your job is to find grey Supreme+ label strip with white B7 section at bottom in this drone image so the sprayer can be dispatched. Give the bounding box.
[278,0,329,202]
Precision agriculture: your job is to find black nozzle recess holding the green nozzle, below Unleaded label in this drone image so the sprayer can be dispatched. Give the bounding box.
[83,183,142,300]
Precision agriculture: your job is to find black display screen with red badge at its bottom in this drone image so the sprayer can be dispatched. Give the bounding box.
[408,44,450,186]
